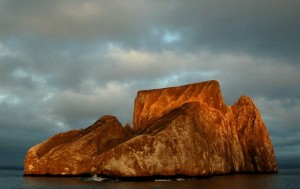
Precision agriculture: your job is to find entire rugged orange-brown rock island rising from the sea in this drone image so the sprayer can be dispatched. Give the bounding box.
[24,81,277,177]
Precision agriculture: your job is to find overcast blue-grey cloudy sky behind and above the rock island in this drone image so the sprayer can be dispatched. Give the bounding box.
[0,0,300,168]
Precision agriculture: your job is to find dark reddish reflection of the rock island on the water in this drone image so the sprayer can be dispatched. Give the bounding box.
[23,174,284,189]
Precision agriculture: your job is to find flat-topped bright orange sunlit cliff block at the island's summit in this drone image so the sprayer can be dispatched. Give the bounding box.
[133,80,225,131]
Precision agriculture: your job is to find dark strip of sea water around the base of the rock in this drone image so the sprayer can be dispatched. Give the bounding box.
[0,169,300,189]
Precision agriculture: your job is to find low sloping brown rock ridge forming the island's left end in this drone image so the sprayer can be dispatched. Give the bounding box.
[24,116,132,175]
